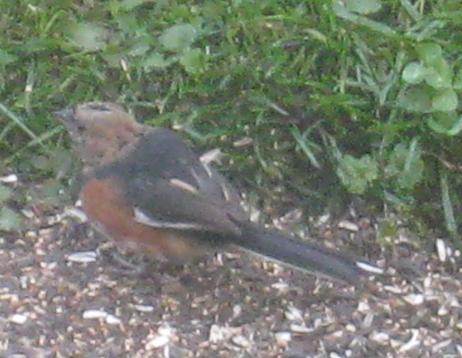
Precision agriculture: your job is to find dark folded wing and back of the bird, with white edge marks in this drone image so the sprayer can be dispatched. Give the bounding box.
[113,128,247,235]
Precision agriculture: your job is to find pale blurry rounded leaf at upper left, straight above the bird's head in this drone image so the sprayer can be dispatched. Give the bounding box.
[69,22,108,51]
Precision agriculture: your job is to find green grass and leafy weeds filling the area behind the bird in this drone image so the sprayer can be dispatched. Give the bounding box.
[0,0,462,243]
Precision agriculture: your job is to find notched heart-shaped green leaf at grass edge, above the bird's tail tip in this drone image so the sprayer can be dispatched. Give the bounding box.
[337,154,378,194]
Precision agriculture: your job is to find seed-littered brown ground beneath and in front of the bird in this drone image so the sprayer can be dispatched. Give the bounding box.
[0,203,462,357]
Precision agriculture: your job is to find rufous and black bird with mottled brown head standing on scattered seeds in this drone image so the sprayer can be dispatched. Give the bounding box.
[54,102,380,286]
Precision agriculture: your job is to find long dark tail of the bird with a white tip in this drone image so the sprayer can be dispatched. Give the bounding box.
[234,223,382,286]
